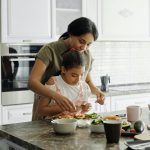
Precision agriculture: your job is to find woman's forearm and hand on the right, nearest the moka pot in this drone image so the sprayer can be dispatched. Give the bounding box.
[86,73,105,104]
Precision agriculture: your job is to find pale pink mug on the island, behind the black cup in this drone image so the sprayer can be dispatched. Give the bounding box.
[127,105,142,122]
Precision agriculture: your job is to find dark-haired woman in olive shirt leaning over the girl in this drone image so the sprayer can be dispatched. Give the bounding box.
[28,17,104,119]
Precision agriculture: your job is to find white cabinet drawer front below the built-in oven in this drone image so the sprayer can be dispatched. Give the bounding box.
[2,104,33,124]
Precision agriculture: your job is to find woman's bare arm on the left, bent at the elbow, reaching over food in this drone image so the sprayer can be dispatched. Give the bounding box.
[28,58,76,111]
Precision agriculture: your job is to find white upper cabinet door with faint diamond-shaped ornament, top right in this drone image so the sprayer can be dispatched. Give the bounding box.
[98,0,150,40]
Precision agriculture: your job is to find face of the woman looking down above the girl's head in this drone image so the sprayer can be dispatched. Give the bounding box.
[69,33,94,52]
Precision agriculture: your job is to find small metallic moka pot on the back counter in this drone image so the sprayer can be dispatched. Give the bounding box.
[100,75,110,92]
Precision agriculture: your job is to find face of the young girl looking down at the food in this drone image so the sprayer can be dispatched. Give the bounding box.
[61,66,84,85]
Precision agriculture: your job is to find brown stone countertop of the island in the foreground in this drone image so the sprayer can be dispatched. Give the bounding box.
[0,109,150,150]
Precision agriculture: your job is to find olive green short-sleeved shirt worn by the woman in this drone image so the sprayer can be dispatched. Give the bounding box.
[36,38,92,84]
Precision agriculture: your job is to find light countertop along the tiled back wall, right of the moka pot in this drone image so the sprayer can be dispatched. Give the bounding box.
[99,83,150,96]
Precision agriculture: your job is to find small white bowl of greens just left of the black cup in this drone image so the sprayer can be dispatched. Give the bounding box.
[90,124,105,133]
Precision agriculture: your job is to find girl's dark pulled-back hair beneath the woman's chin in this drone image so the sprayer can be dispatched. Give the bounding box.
[62,50,84,69]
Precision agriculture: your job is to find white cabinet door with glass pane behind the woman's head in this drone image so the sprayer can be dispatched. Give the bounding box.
[52,0,86,37]
